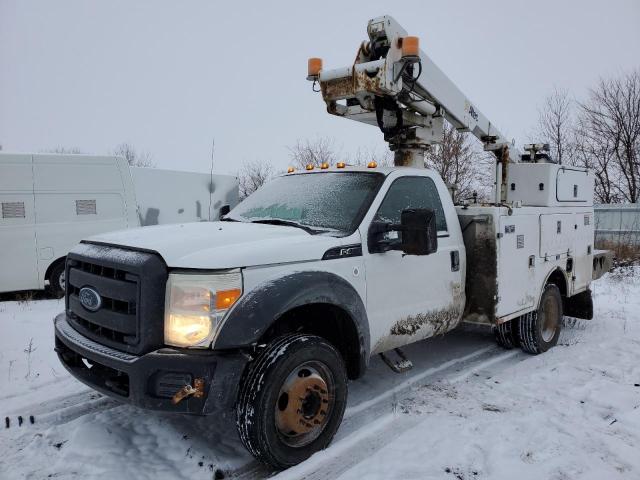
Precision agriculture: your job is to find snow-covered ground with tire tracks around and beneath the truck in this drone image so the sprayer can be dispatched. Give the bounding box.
[0,269,640,480]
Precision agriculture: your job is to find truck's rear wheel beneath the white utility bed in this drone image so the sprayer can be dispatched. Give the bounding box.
[519,284,562,354]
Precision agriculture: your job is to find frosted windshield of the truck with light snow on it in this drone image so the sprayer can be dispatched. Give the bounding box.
[224,172,384,234]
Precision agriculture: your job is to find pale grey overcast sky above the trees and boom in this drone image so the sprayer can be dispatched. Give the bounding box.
[0,0,640,173]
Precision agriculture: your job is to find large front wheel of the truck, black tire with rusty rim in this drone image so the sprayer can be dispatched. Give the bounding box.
[236,334,347,469]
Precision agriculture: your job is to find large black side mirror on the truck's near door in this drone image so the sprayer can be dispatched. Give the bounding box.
[400,208,438,255]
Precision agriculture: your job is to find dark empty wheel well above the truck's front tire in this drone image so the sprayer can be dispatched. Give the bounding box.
[258,303,364,379]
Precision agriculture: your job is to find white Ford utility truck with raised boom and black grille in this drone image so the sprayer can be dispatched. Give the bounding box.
[55,16,598,468]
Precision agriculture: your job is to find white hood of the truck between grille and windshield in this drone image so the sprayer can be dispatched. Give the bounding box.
[88,222,345,269]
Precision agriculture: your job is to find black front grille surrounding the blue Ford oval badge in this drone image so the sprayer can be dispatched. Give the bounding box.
[66,244,167,353]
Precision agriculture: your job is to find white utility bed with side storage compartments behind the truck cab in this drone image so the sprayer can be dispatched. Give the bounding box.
[456,206,594,324]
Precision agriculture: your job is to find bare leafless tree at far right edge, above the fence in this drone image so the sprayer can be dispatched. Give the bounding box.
[580,69,640,203]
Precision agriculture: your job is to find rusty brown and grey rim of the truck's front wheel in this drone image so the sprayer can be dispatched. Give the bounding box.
[275,362,335,447]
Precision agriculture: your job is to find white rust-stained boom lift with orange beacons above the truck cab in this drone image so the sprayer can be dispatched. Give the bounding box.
[307,15,532,203]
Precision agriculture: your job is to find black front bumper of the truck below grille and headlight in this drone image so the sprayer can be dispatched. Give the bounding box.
[54,313,248,417]
